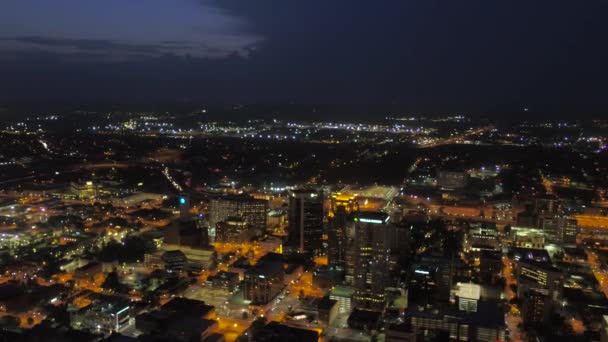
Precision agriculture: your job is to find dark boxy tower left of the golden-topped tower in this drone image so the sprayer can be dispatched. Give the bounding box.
[289,190,323,253]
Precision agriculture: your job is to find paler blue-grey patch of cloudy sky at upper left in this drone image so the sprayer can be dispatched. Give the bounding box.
[0,0,262,61]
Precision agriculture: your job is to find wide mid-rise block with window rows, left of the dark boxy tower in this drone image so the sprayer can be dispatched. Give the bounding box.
[209,195,268,230]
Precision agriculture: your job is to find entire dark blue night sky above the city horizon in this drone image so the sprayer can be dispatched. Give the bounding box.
[0,0,608,117]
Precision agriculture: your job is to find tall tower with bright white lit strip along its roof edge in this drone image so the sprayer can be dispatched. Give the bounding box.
[353,212,394,309]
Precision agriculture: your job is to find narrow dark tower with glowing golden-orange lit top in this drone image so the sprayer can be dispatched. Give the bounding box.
[327,193,359,270]
